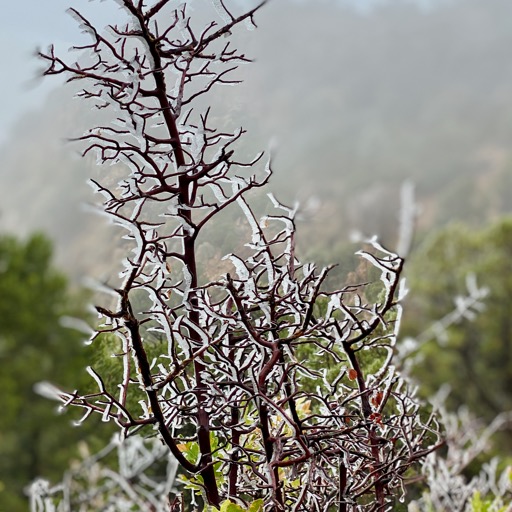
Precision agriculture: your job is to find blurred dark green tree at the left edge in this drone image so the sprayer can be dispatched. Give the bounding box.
[0,234,97,511]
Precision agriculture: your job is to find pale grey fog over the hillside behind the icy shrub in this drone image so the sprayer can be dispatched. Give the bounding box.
[0,0,512,276]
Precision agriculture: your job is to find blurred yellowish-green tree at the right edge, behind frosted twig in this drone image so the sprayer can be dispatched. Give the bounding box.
[404,217,512,428]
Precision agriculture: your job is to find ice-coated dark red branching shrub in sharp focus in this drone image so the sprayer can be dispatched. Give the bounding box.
[34,0,442,512]
